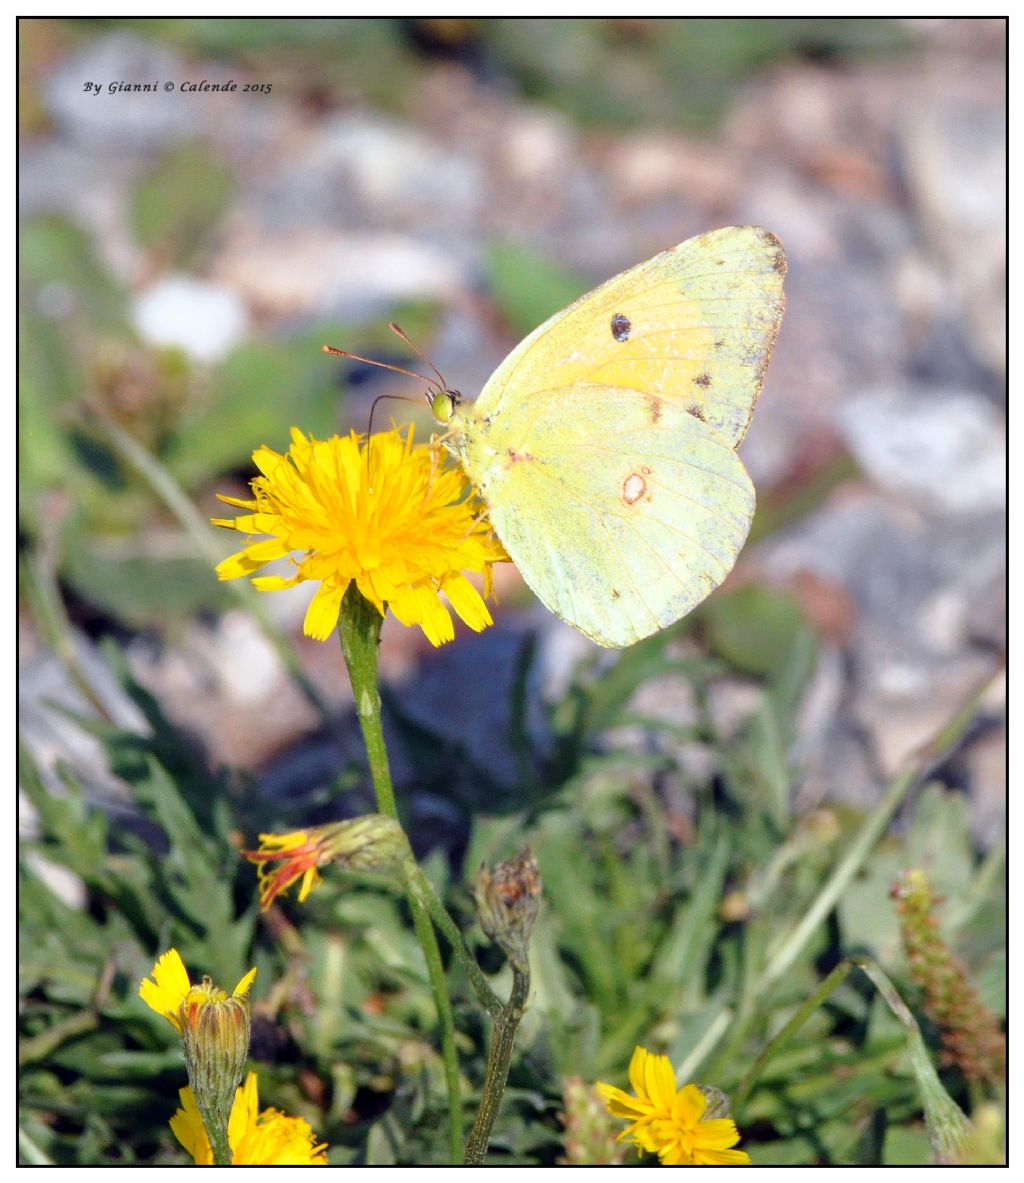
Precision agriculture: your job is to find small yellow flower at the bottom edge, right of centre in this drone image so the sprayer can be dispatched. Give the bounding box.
[597,1047,750,1166]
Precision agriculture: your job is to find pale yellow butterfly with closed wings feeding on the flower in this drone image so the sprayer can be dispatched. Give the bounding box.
[325,226,786,648]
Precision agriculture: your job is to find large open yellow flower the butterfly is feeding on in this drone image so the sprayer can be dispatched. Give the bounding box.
[212,427,507,645]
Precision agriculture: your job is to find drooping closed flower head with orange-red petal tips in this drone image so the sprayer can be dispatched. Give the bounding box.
[244,814,408,911]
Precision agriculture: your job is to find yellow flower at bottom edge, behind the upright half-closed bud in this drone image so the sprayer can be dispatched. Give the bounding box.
[170,1072,328,1166]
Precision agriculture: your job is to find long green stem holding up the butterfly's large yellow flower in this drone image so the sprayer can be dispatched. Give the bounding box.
[338,583,462,1164]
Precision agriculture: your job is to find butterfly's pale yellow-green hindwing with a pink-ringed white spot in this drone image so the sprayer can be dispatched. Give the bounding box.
[460,383,754,647]
